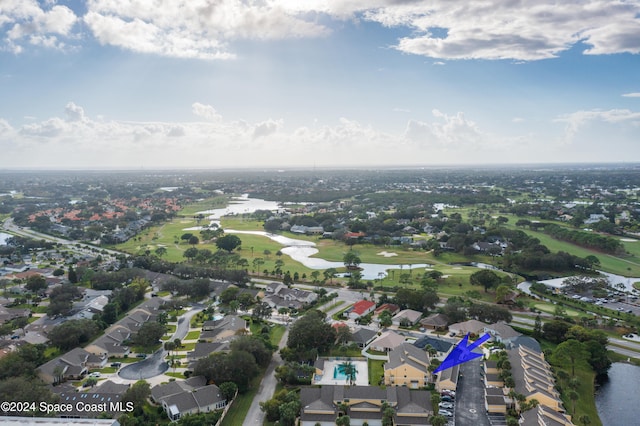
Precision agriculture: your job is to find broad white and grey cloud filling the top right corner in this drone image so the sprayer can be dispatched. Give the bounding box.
[363,0,640,61]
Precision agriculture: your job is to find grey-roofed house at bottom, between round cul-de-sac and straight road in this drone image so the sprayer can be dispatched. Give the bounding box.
[151,376,227,421]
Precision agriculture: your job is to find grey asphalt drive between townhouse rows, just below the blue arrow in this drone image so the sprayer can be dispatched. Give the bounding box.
[454,359,491,426]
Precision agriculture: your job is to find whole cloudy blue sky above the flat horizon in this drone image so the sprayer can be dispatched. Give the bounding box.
[0,0,640,170]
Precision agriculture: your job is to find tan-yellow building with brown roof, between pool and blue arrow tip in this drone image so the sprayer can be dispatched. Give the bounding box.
[384,342,431,389]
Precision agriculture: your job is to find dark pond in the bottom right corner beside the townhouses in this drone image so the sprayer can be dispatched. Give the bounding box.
[596,362,640,426]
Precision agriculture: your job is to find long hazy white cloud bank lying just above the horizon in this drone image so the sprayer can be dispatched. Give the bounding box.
[0,102,640,168]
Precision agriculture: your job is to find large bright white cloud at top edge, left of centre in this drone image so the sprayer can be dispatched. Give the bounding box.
[84,0,327,59]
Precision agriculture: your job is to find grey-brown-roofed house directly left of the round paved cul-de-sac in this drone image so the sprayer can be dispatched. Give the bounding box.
[37,348,107,384]
